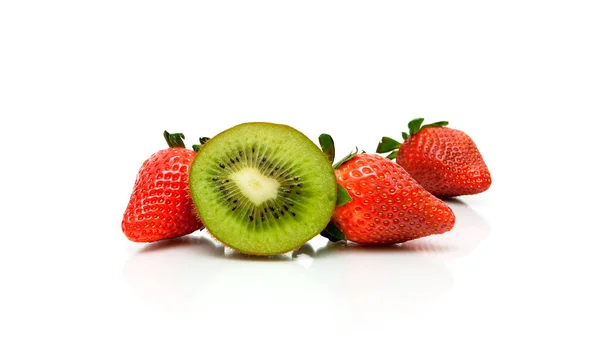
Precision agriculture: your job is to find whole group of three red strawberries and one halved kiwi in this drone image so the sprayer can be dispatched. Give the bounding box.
[121,118,491,256]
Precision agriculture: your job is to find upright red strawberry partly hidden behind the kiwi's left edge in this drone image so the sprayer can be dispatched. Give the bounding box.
[121,131,204,242]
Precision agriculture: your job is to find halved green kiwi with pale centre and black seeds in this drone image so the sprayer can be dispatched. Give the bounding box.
[189,122,337,255]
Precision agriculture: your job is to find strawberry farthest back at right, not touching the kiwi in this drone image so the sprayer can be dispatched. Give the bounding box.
[377,118,492,197]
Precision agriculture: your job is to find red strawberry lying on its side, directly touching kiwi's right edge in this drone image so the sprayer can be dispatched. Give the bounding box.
[320,135,455,244]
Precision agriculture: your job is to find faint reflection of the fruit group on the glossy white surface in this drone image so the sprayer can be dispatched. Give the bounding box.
[124,200,490,329]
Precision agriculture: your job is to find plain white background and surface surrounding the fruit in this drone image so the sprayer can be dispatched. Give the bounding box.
[0,0,600,357]
